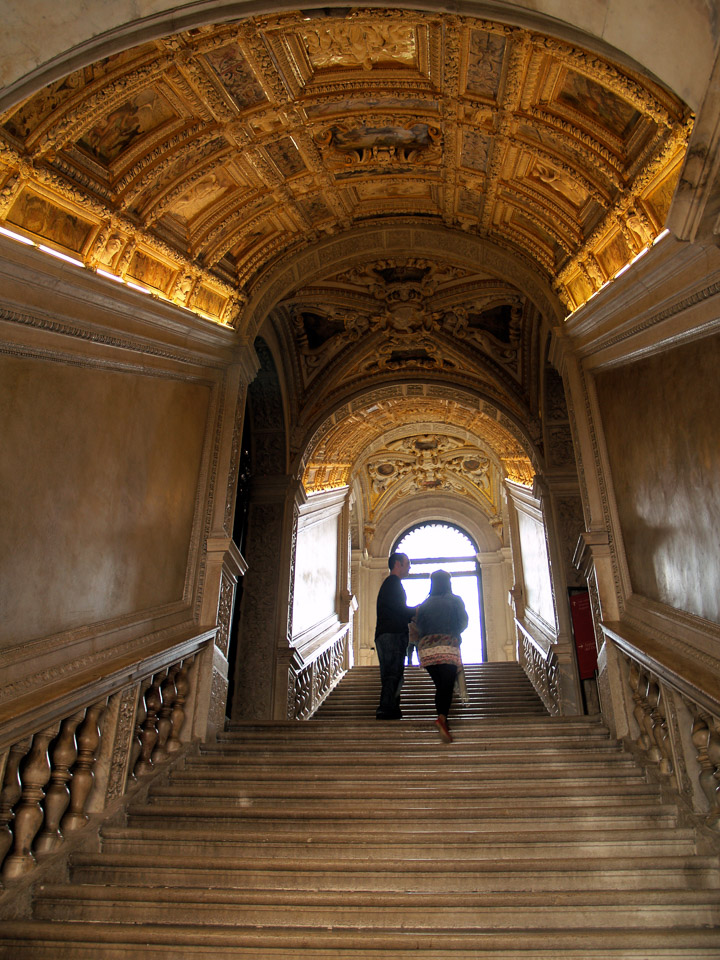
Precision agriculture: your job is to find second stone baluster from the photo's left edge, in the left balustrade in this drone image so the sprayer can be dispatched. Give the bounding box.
[2,723,58,880]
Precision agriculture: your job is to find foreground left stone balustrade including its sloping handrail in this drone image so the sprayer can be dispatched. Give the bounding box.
[0,627,217,885]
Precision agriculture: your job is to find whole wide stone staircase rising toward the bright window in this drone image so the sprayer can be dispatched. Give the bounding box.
[0,664,720,960]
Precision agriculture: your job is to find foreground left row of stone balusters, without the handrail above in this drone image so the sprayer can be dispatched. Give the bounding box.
[0,644,197,885]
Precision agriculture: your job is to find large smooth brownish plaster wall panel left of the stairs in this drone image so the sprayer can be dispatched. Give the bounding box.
[0,338,210,647]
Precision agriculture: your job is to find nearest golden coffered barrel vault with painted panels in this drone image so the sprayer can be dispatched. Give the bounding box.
[0,9,691,330]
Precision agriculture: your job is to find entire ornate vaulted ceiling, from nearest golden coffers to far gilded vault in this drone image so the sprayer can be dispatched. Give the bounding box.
[0,8,692,522]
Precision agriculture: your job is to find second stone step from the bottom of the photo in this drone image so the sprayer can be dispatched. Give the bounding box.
[34,884,720,934]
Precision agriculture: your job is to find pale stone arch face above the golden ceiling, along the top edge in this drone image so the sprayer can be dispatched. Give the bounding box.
[0,0,720,116]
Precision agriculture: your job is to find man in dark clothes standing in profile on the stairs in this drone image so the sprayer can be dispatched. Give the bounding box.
[375,553,415,720]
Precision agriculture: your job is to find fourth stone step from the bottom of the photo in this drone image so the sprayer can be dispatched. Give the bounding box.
[102,818,697,863]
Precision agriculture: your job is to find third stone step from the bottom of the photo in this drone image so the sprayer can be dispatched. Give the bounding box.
[70,853,720,893]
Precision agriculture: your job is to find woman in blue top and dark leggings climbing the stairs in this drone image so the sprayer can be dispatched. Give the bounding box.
[416,570,468,743]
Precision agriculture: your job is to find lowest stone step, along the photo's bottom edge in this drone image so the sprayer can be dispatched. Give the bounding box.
[0,920,720,960]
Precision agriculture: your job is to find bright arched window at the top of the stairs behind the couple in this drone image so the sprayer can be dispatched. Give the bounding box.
[393,523,487,663]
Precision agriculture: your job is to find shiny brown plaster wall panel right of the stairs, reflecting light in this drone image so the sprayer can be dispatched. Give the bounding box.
[596,334,720,623]
